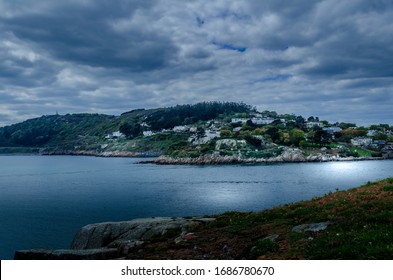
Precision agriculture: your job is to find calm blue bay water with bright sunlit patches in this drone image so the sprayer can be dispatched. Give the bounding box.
[0,155,393,259]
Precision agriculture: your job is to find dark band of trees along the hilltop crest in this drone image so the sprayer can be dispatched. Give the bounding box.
[146,102,255,130]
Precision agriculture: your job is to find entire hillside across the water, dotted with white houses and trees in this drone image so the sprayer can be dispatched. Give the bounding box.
[0,102,393,161]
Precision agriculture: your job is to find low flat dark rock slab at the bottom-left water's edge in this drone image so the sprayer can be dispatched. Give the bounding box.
[14,248,119,260]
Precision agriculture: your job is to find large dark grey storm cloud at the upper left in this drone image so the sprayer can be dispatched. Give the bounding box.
[2,1,177,71]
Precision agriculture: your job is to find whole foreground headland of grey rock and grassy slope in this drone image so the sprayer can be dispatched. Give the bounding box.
[15,177,393,260]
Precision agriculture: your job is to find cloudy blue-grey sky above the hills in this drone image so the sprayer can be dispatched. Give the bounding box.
[0,0,393,126]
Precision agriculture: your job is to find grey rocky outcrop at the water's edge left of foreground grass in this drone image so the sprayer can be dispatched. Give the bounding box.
[14,217,215,260]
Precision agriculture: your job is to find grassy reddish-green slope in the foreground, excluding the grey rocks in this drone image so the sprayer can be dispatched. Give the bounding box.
[129,178,393,259]
